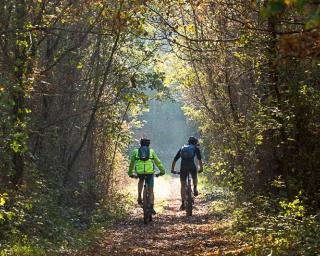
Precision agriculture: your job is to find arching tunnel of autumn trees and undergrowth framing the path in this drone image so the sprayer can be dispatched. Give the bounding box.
[0,0,320,255]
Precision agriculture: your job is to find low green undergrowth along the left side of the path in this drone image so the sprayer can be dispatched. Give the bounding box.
[0,183,130,256]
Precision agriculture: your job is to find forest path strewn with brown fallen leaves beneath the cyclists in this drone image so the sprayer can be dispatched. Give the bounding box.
[77,178,246,256]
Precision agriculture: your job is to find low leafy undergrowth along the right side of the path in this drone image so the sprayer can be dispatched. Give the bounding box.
[201,175,320,256]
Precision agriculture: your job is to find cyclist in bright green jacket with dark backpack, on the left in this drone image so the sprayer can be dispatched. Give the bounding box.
[128,138,165,214]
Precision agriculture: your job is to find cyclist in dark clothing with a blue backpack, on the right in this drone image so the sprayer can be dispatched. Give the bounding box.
[171,137,203,210]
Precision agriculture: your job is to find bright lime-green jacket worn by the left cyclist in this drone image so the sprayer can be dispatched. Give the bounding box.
[128,148,165,175]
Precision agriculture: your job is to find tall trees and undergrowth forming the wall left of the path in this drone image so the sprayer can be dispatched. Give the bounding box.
[0,0,170,255]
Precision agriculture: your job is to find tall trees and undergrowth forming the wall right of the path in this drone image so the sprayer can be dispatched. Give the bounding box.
[153,0,320,255]
